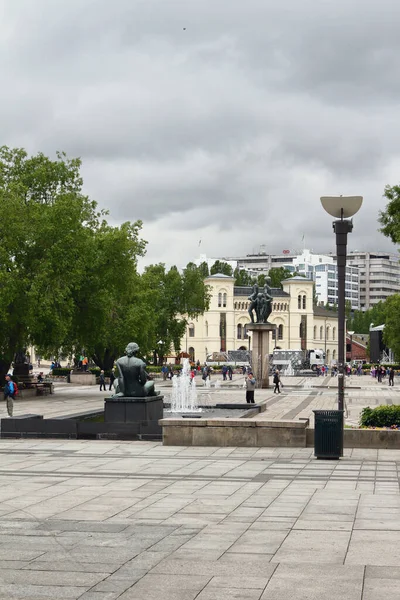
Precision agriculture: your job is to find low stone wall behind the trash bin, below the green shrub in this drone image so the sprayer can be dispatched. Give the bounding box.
[307,428,400,450]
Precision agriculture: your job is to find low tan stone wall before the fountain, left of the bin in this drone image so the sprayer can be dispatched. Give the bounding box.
[160,419,308,448]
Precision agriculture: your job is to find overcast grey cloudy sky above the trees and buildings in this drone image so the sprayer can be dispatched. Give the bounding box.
[0,0,400,265]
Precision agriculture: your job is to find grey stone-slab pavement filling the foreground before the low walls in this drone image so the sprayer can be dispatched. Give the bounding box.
[0,440,400,600]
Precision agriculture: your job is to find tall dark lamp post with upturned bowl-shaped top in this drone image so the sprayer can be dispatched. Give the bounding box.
[321,196,363,410]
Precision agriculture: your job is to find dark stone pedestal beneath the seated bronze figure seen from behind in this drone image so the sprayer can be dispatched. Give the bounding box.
[104,396,164,435]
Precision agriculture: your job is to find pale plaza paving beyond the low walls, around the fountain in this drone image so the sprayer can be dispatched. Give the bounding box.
[10,375,400,425]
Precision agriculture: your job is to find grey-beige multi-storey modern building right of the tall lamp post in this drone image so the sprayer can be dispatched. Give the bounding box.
[347,251,400,310]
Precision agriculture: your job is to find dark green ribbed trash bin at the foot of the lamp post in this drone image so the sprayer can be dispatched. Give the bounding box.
[313,410,343,459]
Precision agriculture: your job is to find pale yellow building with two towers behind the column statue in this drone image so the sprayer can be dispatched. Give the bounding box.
[181,274,338,365]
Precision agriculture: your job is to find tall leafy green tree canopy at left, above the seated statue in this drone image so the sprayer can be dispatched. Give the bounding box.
[0,147,146,381]
